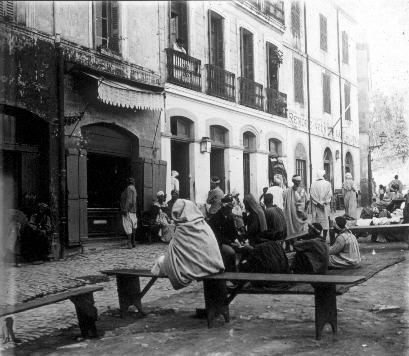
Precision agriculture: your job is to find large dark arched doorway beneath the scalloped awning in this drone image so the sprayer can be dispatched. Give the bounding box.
[79,124,141,237]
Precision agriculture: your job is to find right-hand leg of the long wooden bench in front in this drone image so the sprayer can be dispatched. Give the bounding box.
[314,284,337,340]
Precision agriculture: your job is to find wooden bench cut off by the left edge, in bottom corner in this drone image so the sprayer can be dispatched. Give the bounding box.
[0,286,103,337]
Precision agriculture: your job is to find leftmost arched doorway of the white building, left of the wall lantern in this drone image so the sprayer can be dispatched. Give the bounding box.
[170,116,193,199]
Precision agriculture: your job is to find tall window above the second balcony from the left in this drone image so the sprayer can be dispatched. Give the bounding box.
[209,11,224,68]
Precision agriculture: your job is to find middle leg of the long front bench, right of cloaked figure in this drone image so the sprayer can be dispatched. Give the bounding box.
[203,280,230,328]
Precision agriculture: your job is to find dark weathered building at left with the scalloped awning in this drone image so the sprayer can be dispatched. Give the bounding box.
[0,1,166,252]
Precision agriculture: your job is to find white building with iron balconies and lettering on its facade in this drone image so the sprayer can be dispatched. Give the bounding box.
[162,1,359,207]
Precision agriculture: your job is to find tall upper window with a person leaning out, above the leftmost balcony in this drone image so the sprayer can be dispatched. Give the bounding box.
[170,1,188,52]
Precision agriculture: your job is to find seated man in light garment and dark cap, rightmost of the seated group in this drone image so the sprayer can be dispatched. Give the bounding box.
[329,216,361,268]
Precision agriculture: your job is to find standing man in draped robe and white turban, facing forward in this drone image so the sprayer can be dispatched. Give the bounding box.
[284,174,308,237]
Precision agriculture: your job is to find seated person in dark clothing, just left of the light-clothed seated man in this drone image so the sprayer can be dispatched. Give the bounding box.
[291,223,329,274]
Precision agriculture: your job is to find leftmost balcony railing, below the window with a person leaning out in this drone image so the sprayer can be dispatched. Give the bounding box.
[166,48,202,91]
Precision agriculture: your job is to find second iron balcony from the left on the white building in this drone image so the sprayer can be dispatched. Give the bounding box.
[205,64,236,101]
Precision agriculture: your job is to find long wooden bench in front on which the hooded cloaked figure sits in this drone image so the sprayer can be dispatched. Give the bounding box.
[101,269,365,340]
